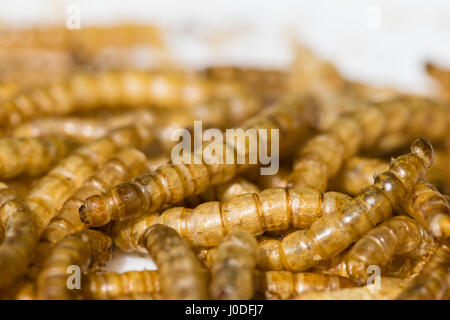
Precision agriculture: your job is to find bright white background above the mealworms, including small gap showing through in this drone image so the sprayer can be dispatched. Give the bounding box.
[0,0,450,271]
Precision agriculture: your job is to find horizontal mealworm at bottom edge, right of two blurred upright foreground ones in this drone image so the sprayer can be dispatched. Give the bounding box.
[255,271,355,300]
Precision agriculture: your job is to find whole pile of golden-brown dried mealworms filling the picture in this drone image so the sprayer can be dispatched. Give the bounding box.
[0,25,450,300]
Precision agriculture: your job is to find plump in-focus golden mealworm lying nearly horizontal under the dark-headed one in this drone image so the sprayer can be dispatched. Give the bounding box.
[112,188,350,251]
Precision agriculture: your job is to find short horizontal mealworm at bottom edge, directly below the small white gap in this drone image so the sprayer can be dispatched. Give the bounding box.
[85,270,160,300]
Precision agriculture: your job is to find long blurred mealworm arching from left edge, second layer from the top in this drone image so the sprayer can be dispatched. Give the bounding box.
[0,71,260,127]
